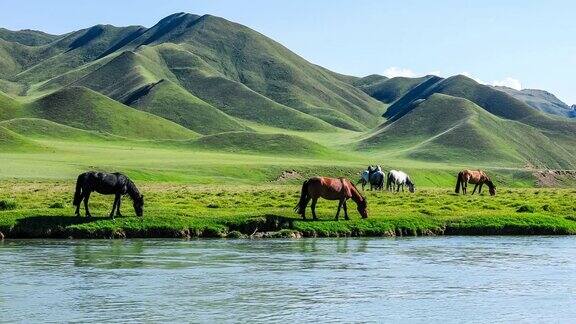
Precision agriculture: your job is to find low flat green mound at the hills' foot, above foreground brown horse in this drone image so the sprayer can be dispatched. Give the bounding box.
[191,132,330,157]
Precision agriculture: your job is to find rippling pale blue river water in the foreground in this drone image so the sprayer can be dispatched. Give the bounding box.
[0,236,576,323]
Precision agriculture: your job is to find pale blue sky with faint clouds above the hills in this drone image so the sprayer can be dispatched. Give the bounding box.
[0,0,576,104]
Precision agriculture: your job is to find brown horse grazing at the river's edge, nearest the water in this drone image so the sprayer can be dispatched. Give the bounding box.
[294,177,368,220]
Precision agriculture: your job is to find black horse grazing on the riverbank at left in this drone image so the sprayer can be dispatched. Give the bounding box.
[74,171,144,219]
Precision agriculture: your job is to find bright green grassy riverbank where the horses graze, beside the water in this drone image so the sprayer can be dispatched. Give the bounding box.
[0,181,576,238]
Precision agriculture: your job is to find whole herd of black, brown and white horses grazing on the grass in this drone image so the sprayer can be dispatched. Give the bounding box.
[73,165,496,220]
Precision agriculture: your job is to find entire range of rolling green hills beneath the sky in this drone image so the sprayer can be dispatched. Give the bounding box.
[0,13,576,169]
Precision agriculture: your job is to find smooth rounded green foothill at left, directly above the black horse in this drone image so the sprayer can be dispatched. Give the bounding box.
[0,87,198,139]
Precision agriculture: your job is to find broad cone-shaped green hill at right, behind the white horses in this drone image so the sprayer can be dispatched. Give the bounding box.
[363,94,575,168]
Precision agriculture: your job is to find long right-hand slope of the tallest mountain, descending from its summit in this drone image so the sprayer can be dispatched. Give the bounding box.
[135,15,381,129]
